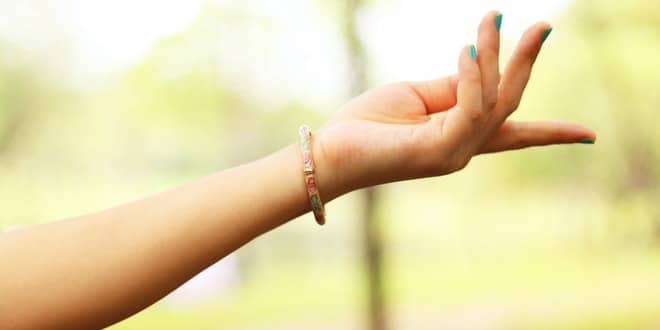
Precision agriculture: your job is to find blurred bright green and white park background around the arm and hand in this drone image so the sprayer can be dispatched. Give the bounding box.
[0,0,660,330]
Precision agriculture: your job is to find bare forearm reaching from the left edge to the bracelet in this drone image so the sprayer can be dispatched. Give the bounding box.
[0,141,340,328]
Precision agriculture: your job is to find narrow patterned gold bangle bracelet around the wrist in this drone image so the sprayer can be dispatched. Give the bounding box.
[298,125,325,225]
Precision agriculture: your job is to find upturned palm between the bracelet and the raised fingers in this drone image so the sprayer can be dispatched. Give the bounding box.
[321,83,454,191]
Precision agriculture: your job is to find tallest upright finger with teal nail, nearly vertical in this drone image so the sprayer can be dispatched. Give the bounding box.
[477,11,502,111]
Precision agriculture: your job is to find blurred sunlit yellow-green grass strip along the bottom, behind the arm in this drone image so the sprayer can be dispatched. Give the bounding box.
[112,251,660,330]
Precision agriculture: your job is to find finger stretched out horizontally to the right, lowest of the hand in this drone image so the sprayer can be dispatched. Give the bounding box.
[479,120,596,153]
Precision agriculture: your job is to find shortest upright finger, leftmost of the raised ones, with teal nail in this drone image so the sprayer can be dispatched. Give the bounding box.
[456,45,482,121]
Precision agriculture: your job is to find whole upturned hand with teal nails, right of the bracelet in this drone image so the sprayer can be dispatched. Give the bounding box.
[315,12,595,198]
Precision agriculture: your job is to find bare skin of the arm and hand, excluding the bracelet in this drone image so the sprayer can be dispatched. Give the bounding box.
[0,12,595,329]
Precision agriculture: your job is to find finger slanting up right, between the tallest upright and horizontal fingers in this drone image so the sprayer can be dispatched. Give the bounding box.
[497,22,552,117]
